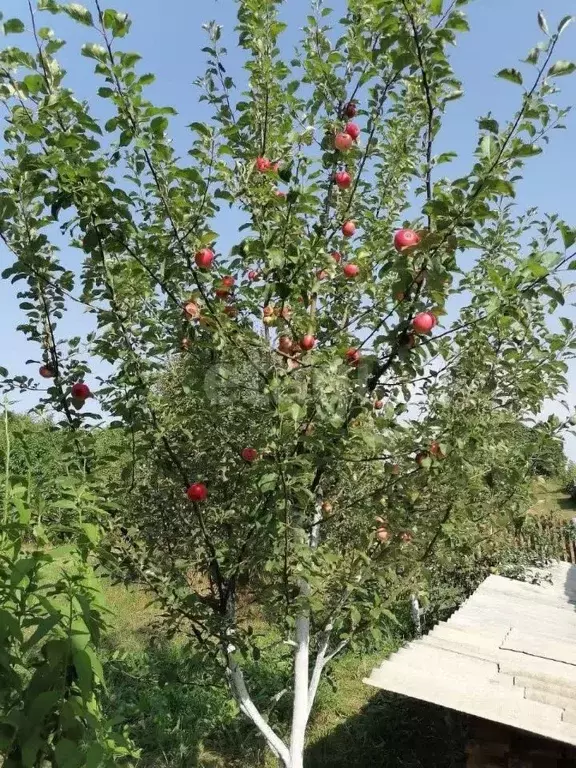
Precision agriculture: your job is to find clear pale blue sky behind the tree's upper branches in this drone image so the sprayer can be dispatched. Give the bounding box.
[0,0,576,459]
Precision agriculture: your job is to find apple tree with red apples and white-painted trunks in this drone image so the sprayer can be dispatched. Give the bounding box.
[0,0,576,768]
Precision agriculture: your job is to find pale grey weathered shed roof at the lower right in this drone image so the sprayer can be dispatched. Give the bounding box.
[365,563,576,745]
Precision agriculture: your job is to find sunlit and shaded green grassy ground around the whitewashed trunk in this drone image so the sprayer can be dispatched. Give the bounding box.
[94,481,576,768]
